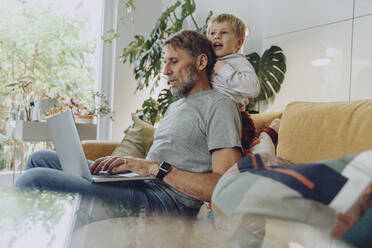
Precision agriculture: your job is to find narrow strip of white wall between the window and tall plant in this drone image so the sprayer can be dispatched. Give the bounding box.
[112,0,162,140]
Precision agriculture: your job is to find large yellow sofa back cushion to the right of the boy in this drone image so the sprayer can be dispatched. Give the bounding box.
[277,100,372,163]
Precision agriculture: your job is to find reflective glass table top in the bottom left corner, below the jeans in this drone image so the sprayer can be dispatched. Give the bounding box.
[0,188,79,247]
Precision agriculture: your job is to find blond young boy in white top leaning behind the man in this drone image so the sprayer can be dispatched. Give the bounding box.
[207,14,280,154]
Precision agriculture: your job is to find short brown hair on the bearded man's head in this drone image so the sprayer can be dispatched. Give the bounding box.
[164,30,216,80]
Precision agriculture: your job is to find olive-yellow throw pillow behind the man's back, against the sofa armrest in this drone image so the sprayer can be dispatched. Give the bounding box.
[112,114,155,158]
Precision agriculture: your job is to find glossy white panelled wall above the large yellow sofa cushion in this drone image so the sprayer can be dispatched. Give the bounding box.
[261,0,372,112]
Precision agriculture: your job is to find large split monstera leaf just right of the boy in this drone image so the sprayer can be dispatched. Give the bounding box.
[246,46,287,110]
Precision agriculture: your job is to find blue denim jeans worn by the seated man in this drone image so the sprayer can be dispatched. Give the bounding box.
[16,150,198,217]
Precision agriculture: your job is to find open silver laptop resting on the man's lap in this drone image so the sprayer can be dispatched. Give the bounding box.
[47,110,155,183]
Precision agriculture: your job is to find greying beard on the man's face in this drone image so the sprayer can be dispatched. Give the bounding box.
[171,63,199,97]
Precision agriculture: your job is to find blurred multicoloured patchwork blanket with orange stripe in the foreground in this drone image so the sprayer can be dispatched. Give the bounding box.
[212,151,372,247]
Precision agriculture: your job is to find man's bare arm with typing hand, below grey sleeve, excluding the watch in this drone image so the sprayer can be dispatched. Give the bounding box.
[90,148,242,201]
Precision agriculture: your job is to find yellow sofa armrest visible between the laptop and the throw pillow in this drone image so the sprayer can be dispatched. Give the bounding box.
[82,140,120,160]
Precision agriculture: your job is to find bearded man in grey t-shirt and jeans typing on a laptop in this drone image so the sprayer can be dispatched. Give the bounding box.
[16,31,241,216]
